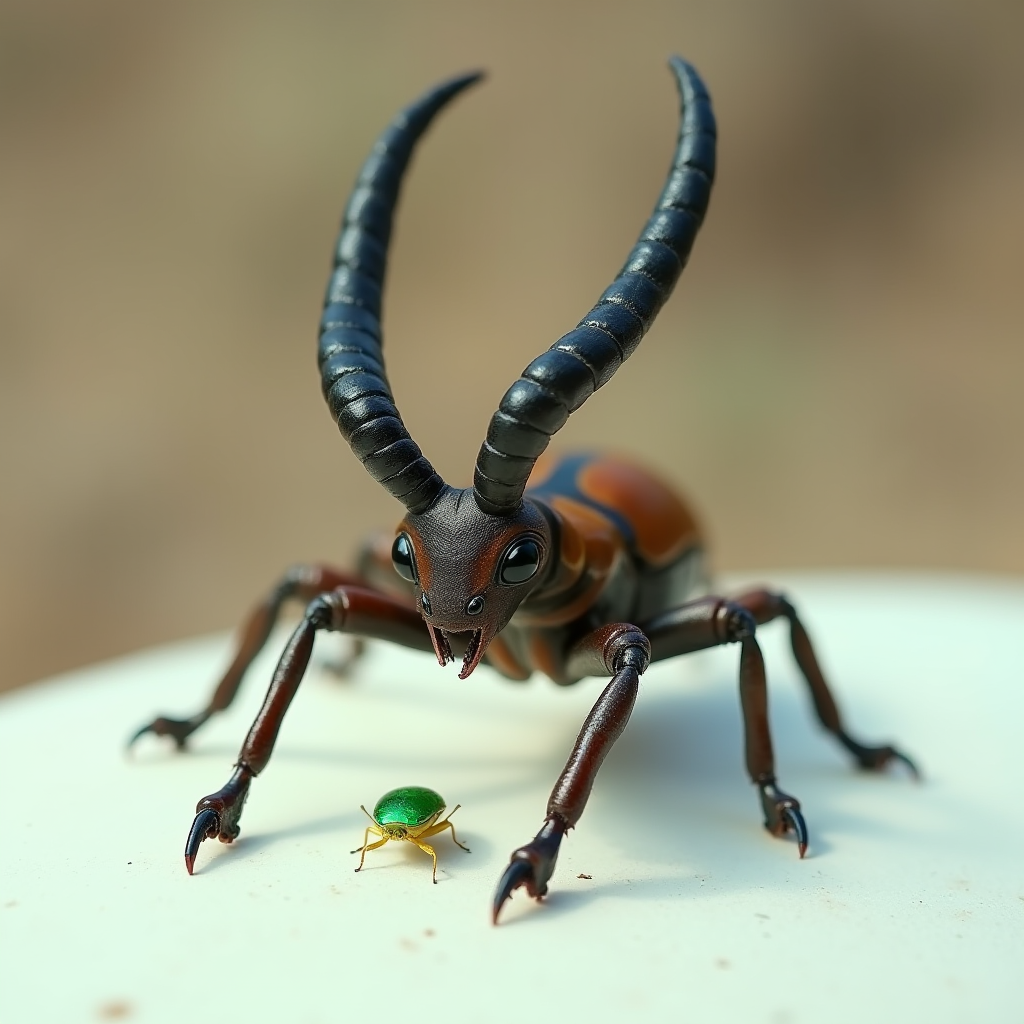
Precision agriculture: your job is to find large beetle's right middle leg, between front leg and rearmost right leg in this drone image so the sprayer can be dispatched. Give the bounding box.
[644,597,808,857]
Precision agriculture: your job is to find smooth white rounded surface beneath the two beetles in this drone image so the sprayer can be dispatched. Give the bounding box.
[0,575,1024,1024]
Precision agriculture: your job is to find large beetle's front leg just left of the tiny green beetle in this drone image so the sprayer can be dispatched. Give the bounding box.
[185,586,433,874]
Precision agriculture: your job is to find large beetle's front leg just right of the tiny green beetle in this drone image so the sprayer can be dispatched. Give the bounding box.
[492,623,650,925]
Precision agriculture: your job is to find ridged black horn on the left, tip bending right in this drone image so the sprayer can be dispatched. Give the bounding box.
[319,73,480,513]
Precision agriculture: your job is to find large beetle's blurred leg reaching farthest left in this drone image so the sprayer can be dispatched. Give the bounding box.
[128,565,366,750]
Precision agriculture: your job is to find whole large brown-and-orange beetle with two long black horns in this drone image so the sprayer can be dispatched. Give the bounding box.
[133,57,914,923]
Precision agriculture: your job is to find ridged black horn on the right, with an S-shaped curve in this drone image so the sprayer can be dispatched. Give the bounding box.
[473,57,715,515]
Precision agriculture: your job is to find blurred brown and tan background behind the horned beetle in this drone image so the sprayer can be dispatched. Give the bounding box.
[0,0,1024,687]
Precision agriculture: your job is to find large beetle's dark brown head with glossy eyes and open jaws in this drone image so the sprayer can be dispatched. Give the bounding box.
[391,487,552,679]
